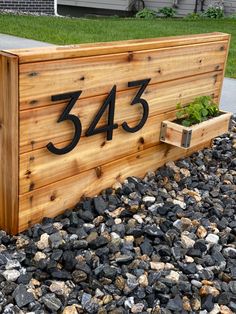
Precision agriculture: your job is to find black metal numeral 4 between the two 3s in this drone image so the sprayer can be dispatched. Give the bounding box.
[86,85,118,141]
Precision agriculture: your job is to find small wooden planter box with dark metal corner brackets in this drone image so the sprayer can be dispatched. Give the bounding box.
[160,111,232,148]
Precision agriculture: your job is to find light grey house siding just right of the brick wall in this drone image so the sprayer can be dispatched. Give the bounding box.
[58,0,130,11]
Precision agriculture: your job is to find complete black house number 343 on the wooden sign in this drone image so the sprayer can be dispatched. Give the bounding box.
[47,79,151,155]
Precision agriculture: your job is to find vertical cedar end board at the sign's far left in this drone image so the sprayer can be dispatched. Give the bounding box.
[0,52,19,233]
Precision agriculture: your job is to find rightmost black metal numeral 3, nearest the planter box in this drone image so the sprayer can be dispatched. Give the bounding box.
[122,79,151,133]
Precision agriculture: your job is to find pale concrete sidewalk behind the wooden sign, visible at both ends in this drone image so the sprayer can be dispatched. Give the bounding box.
[0,34,236,114]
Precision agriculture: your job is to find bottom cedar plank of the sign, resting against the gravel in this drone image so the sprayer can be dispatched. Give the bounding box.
[19,141,210,231]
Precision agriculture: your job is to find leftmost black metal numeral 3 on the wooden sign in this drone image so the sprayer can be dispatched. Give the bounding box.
[47,91,82,155]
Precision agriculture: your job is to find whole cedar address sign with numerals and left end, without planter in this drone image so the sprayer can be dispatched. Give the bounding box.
[0,33,229,233]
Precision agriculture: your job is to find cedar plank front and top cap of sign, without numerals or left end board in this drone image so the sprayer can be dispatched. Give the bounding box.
[0,33,229,233]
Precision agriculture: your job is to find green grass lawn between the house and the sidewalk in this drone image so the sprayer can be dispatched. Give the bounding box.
[0,15,236,78]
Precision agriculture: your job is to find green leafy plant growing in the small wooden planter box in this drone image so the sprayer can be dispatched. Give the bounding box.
[176,96,219,126]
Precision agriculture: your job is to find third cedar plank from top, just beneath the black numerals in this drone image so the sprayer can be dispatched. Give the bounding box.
[20,111,175,194]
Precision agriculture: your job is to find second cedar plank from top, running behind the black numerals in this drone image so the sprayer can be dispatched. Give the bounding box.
[20,71,221,153]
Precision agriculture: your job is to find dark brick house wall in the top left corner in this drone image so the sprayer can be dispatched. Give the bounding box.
[0,0,55,14]
